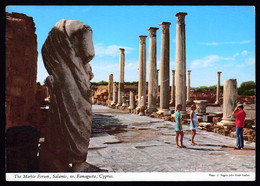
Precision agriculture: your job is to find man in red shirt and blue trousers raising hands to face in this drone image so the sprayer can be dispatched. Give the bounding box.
[232,104,246,150]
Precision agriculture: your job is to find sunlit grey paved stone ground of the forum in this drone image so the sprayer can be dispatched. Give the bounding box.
[87,105,256,173]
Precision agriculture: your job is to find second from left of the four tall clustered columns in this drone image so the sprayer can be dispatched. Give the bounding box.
[148,27,159,113]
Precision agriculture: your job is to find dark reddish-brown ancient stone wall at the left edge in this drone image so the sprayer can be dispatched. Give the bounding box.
[5,13,38,129]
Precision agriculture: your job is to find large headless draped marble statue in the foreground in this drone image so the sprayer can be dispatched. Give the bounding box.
[39,19,99,172]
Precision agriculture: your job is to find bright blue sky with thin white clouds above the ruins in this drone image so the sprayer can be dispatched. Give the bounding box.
[6,6,255,87]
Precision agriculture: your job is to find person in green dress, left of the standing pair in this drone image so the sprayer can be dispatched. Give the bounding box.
[175,104,186,148]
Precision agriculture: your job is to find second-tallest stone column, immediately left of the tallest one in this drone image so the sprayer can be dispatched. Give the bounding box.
[158,22,171,115]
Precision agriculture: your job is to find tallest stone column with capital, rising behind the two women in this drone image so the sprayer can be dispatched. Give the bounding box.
[175,12,187,115]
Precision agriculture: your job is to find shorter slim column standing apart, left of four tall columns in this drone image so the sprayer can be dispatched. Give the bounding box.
[117,48,125,106]
